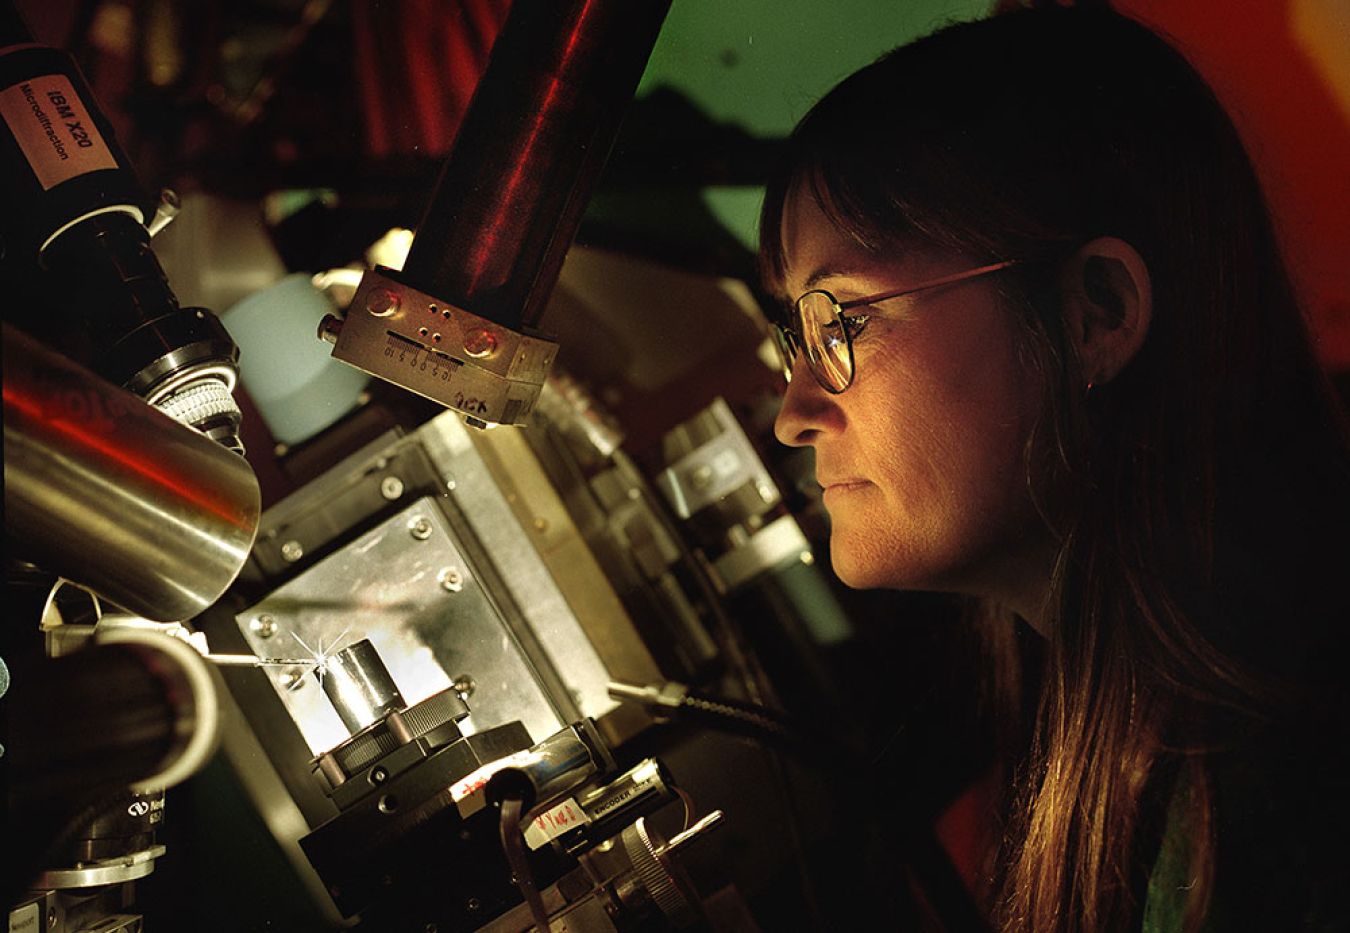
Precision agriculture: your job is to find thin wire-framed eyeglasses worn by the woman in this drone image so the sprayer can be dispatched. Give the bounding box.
[774,259,1017,396]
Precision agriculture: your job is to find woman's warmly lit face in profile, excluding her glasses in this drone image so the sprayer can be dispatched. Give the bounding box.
[775,190,1050,618]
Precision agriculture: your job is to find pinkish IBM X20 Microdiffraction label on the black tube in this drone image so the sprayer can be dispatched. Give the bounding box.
[0,74,117,190]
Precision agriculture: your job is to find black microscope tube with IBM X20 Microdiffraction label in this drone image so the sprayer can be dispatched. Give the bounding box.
[0,32,243,454]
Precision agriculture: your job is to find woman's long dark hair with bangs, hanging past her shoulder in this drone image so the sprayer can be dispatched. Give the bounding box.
[760,8,1350,933]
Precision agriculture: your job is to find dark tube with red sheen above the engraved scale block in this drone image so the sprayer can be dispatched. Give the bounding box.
[402,0,670,329]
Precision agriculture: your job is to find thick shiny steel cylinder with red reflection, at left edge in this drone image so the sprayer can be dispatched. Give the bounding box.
[4,325,261,621]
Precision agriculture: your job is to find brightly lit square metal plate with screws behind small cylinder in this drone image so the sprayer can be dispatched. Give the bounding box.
[235,497,564,755]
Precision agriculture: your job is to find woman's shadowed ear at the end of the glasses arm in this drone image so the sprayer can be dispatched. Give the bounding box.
[1061,243,1153,385]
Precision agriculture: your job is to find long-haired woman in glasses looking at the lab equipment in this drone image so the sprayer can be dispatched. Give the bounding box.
[761,8,1350,933]
